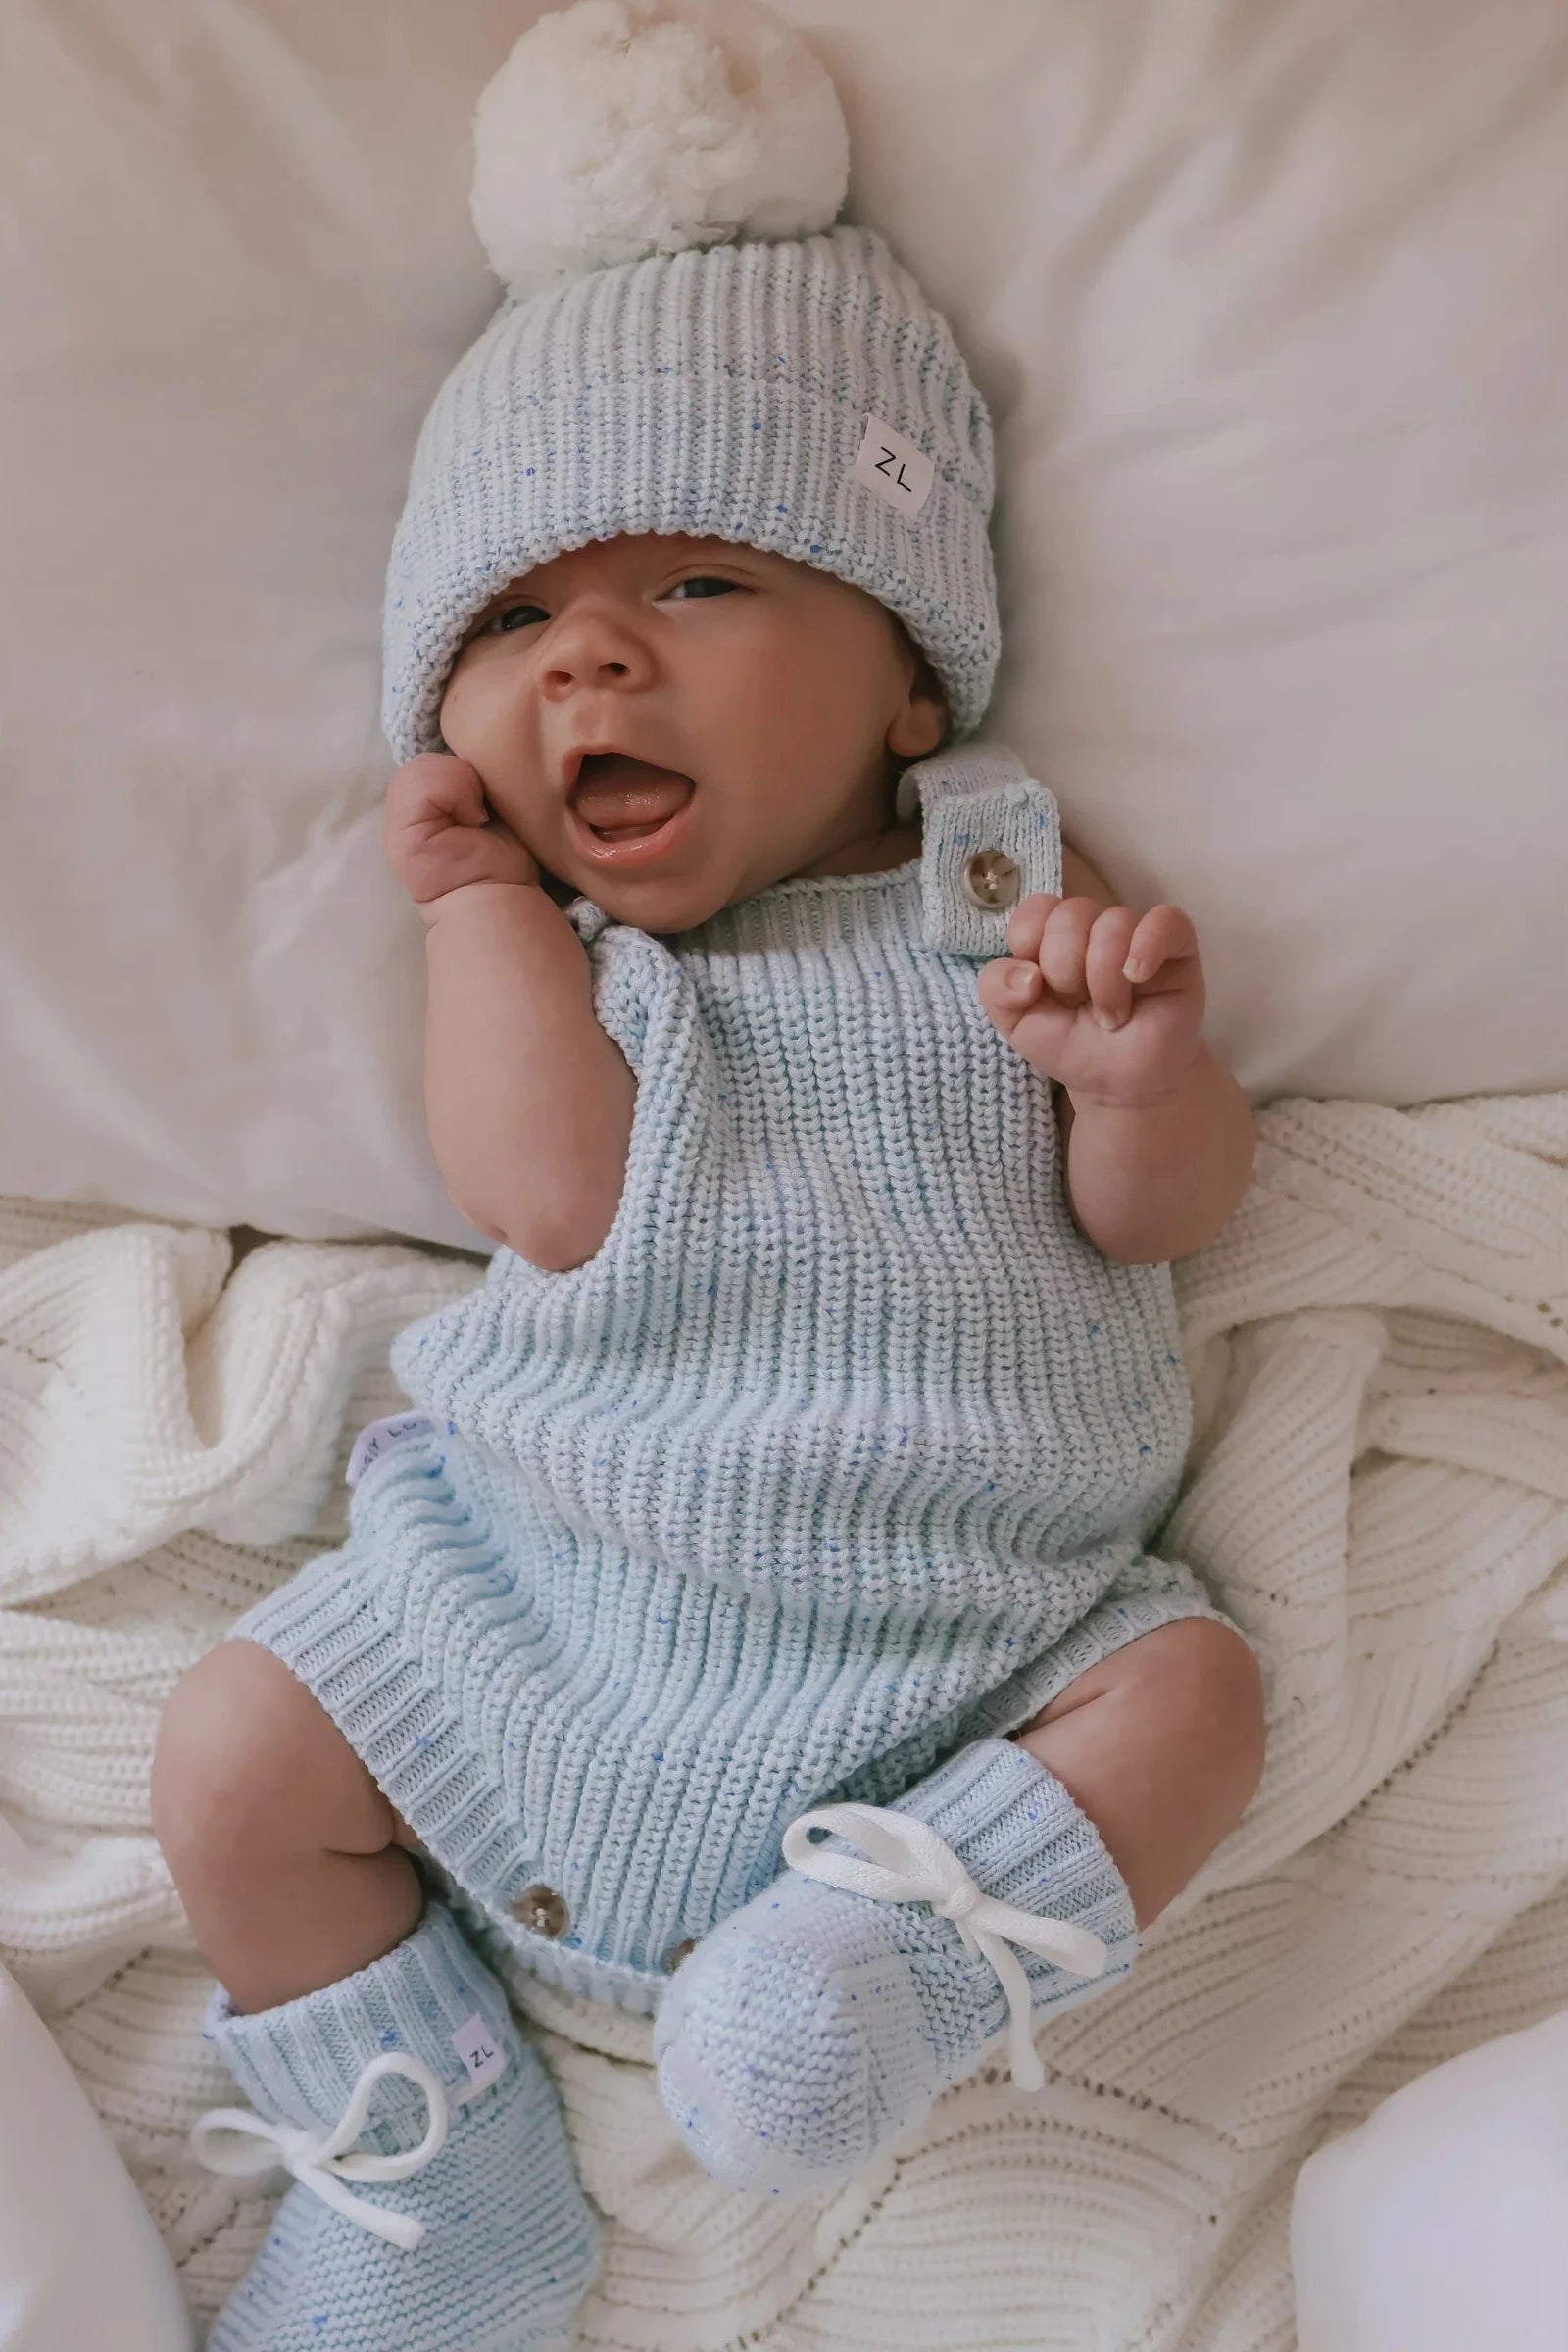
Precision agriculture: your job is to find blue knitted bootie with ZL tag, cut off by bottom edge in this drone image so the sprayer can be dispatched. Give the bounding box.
[193,1905,597,2352]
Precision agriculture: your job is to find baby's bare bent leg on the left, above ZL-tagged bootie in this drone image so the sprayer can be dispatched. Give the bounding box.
[153,1642,423,2009]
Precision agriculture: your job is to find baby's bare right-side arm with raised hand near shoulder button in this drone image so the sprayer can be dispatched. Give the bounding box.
[980,845,1253,1265]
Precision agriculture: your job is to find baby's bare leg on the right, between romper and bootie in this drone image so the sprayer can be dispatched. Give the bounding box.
[1013,1618,1262,1927]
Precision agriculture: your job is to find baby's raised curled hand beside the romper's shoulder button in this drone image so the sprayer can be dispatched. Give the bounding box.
[980,894,1203,1110]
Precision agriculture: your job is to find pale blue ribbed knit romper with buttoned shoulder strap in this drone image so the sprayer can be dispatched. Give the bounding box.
[235,743,1218,2011]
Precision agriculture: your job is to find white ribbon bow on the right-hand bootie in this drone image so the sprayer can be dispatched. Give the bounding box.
[783,1804,1109,2091]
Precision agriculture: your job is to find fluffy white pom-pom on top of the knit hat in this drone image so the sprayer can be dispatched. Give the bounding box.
[472,0,849,294]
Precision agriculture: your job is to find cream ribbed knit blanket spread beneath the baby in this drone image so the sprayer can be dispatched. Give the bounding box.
[0,1096,1568,2352]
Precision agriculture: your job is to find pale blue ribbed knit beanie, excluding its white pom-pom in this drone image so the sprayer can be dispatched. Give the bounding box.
[383,223,1002,760]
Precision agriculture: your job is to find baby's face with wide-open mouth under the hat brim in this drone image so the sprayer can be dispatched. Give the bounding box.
[442,531,945,931]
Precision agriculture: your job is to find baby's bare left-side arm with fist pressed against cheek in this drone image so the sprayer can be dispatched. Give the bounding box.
[385,753,637,1272]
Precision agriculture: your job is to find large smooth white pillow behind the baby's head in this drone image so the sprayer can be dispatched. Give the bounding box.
[0,0,1568,1249]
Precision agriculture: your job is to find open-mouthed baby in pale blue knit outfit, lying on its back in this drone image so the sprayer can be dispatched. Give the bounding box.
[153,0,1262,2352]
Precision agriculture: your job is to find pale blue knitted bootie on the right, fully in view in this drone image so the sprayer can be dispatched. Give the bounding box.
[654,1740,1138,2194]
